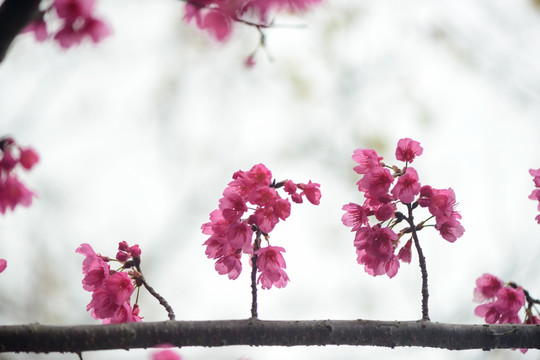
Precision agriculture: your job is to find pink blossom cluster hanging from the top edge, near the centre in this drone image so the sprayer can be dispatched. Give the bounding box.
[185,0,321,41]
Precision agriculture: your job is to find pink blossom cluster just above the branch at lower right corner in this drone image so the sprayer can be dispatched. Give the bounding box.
[474,274,540,324]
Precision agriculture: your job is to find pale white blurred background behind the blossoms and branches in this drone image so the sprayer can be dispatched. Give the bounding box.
[0,0,540,360]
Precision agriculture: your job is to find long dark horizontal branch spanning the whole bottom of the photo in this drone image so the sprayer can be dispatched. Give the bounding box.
[0,318,540,353]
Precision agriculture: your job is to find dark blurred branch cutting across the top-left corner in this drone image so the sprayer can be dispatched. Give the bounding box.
[0,0,40,62]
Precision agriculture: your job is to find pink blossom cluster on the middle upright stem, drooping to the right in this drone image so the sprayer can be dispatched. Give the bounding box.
[202,164,321,289]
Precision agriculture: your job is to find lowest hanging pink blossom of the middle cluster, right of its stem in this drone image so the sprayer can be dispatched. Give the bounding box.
[256,245,289,289]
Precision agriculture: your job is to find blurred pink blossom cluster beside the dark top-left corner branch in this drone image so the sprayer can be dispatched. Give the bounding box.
[24,0,111,49]
